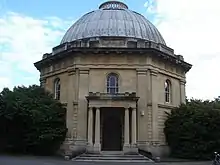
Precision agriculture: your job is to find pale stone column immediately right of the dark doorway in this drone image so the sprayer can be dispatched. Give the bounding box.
[124,108,130,150]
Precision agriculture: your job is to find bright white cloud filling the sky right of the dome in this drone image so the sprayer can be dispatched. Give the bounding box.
[145,0,220,99]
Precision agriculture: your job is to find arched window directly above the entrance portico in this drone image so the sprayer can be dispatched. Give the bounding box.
[107,73,118,94]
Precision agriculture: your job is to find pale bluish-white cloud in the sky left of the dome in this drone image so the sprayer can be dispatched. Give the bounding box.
[0,12,72,89]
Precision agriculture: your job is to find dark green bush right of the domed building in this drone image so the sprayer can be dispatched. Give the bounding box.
[164,99,220,159]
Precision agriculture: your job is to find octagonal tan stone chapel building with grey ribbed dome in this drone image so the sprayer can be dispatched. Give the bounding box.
[35,1,192,156]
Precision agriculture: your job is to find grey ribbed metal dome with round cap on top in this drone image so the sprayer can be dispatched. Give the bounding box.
[61,1,166,45]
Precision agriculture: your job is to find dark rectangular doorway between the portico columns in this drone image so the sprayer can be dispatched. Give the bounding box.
[101,108,124,151]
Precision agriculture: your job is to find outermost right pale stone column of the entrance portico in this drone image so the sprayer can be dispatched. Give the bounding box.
[131,108,137,146]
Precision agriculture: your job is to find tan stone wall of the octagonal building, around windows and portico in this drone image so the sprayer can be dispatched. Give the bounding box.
[41,54,185,157]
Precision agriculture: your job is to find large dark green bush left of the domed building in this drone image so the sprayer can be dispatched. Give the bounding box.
[0,85,67,155]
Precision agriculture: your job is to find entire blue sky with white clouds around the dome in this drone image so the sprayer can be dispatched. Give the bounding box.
[0,0,220,99]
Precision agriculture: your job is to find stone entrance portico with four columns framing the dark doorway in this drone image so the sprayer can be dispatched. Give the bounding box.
[86,92,138,152]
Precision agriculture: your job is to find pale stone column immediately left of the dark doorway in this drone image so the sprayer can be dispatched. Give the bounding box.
[94,108,101,152]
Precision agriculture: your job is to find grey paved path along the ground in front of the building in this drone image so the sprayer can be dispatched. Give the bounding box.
[0,156,212,165]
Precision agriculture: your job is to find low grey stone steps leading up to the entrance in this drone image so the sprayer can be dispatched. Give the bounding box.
[72,152,153,163]
